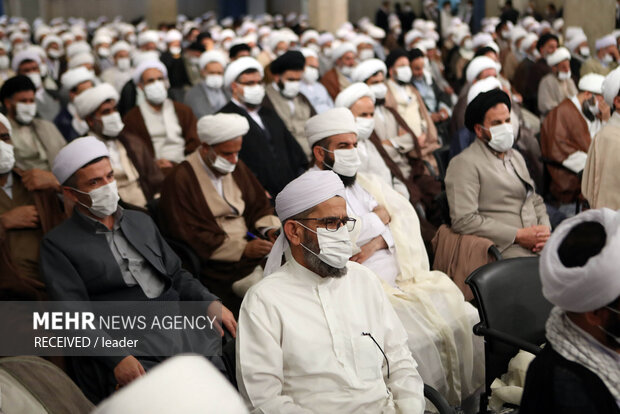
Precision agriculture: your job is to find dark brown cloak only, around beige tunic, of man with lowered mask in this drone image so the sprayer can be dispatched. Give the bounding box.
[160,154,273,313]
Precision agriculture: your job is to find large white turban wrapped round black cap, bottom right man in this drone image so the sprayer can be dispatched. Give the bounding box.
[540,208,620,313]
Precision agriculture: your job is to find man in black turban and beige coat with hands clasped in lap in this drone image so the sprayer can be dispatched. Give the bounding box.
[445,89,550,258]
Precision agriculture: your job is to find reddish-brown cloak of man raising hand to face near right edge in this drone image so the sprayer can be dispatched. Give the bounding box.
[540,99,592,203]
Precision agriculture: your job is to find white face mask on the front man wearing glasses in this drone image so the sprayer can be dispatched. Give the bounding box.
[296,221,353,269]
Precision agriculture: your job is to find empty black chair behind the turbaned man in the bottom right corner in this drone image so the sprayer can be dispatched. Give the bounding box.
[465,257,553,413]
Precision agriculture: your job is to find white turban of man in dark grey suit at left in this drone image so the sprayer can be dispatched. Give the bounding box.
[52,136,110,184]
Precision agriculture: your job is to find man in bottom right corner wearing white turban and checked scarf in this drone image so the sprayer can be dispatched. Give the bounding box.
[519,208,620,414]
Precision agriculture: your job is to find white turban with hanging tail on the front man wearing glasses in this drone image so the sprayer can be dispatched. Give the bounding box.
[264,170,350,276]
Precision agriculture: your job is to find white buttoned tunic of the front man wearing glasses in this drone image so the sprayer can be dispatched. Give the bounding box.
[237,259,425,414]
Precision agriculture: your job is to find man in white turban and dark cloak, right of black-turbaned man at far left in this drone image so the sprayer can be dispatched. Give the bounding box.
[54,67,95,142]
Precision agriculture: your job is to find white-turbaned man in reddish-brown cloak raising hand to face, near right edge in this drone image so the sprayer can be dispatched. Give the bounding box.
[540,73,609,212]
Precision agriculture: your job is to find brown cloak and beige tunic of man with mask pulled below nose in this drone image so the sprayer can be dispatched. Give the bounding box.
[160,151,280,313]
